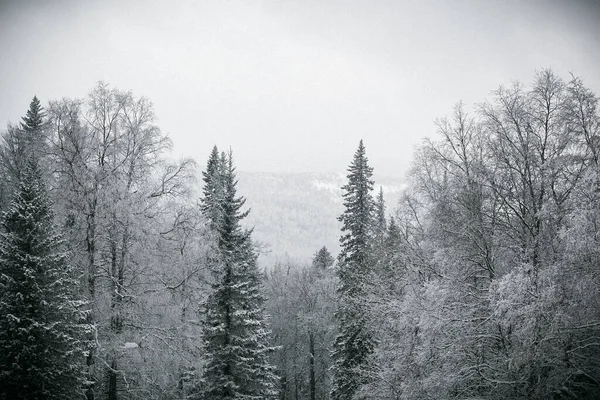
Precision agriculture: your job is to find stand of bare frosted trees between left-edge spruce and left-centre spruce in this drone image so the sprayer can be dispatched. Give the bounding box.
[47,83,199,399]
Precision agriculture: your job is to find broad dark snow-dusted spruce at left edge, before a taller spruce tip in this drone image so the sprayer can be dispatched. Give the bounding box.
[0,160,91,399]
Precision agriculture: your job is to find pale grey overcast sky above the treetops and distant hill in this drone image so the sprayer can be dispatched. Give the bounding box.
[0,0,600,176]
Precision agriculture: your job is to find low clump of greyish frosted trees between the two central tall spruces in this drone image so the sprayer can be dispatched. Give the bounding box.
[266,258,337,400]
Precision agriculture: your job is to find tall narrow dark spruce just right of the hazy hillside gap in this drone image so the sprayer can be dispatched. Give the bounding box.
[331,140,374,400]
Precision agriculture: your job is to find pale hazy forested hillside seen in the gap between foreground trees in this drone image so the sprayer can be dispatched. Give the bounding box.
[238,172,403,265]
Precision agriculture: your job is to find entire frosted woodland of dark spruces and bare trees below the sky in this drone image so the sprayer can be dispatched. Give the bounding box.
[0,70,600,400]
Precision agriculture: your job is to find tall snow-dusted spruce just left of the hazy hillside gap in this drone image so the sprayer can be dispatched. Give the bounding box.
[201,150,277,400]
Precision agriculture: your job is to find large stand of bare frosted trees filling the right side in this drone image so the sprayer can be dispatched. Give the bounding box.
[361,71,600,399]
